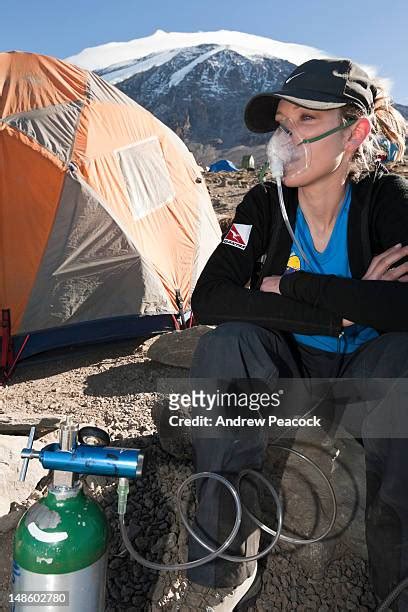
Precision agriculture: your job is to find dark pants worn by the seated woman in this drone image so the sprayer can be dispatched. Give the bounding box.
[189,323,408,612]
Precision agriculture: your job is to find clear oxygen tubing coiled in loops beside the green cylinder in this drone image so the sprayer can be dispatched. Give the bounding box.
[118,445,337,571]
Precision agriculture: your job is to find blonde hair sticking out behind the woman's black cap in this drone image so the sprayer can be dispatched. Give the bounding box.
[339,79,407,182]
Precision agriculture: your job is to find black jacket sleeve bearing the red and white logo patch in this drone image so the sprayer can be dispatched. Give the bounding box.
[191,185,341,336]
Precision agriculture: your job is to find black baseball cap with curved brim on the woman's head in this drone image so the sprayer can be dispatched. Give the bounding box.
[245,59,376,132]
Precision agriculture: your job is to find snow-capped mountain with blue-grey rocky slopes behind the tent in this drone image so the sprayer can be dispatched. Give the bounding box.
[66,30,402,163]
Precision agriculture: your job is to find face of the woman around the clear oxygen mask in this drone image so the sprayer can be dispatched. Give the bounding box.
[275,100,351,187]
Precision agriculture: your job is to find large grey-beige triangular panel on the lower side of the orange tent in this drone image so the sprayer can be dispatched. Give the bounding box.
[22,174,170,332]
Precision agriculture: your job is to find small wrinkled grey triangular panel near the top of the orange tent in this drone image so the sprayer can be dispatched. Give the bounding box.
[5,102,82,165]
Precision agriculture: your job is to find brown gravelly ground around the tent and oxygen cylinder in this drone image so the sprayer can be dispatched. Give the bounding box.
[0,168,408,612]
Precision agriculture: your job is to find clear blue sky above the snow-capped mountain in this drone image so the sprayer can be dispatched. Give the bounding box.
[0,0,408,105]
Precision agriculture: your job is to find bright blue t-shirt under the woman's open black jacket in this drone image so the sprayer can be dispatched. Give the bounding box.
[285,184,379,353]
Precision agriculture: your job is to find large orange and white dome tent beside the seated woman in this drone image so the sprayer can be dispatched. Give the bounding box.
[0,52,220,366]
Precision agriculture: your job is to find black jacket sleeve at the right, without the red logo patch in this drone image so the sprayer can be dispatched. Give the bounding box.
[279,175,408,332]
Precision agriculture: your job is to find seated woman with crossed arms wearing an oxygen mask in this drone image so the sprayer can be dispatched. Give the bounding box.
[156,60,408,612]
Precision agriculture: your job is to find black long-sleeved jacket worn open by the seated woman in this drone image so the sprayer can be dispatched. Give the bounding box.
[191,171,408,336]
